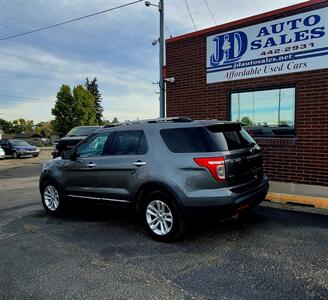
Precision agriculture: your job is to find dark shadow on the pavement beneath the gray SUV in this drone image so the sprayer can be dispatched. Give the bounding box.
[27,199,328,243]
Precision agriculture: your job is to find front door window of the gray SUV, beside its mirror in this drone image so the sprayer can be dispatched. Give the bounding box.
[76,132,111,158]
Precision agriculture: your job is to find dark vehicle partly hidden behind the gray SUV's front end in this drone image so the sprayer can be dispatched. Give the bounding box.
[52,126,102,158]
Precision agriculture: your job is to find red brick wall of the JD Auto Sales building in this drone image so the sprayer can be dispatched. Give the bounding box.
[166,4,328,186]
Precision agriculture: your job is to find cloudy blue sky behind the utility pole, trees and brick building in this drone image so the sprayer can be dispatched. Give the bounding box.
[0,0,303,123]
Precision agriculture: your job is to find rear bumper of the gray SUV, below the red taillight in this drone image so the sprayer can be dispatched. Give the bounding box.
[184,176,269,215]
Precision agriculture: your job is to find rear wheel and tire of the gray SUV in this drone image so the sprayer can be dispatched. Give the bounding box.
[141,191,186,242]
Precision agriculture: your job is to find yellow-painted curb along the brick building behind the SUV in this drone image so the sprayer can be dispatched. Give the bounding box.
[266,192,328,209]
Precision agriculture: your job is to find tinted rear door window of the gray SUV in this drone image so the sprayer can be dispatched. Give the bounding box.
[105,130,147,155]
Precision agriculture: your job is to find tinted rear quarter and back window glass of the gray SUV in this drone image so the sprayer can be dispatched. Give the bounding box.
[160,124,256,153]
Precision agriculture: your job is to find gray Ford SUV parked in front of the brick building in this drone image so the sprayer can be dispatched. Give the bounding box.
[40,117,269,241]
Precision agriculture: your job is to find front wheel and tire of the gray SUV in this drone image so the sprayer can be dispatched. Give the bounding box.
[41,180,65,215]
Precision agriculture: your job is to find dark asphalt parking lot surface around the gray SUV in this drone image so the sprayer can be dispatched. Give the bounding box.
[0,151,328,299]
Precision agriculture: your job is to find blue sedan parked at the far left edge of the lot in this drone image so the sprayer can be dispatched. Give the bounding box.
[0,140,40,158]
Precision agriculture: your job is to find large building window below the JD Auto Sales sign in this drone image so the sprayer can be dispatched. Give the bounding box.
[230,87,295,137]
